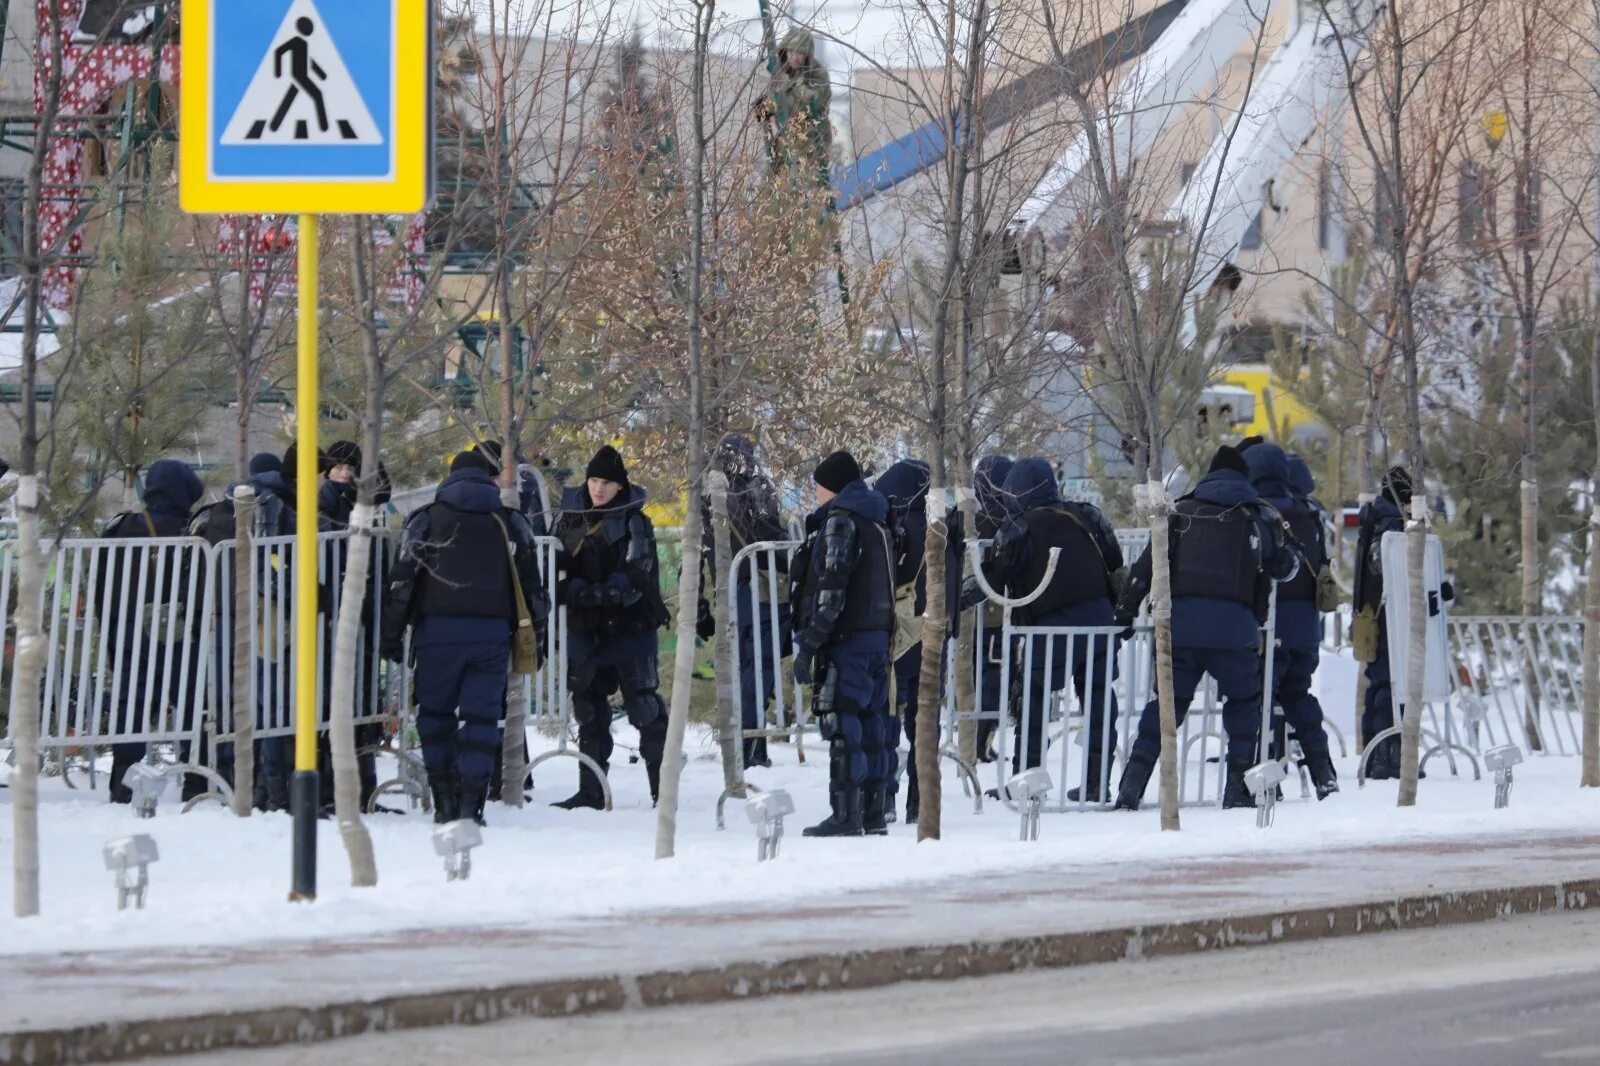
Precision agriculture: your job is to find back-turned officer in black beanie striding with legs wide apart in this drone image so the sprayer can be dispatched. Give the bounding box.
[1117,447,1298,810]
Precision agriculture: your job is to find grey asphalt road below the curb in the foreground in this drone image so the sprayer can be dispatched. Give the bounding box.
[196,914,1600,1066]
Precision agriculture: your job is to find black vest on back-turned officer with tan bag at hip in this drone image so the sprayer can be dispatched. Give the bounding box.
[418,504,517,619]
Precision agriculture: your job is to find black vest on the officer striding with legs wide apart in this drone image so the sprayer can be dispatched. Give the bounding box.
[1171,498,1261,615]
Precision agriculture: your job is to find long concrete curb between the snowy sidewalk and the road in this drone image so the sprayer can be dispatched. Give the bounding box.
[0,879,1600,1066]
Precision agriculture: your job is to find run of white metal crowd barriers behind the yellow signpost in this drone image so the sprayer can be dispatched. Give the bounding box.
[0,531,576,797]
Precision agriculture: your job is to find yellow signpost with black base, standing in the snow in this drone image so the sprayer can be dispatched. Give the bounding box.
[290,214,322,903]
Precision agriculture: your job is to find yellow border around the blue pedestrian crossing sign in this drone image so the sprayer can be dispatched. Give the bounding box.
[178,0,434,214]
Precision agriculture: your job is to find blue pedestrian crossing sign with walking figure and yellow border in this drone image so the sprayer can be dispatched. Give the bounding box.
[179,0,434,214]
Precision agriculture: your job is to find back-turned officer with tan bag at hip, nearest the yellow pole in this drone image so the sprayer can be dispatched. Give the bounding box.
[382,456,546,823]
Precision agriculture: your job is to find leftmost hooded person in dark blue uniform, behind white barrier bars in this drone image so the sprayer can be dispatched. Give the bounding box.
[100,459,205,804]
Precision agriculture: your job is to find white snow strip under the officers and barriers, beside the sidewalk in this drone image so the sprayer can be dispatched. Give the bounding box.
[0,646,1600,954]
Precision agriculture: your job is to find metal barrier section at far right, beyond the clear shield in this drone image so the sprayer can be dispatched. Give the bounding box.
[1450,616,1584,755]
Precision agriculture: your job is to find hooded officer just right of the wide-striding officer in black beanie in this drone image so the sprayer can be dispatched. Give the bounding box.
[1245,443,1339,800]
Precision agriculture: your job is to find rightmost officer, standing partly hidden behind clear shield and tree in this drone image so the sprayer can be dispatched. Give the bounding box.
[1354,466,1411,781]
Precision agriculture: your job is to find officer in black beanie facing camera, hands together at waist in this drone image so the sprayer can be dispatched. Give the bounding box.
[555,445,667,810]
